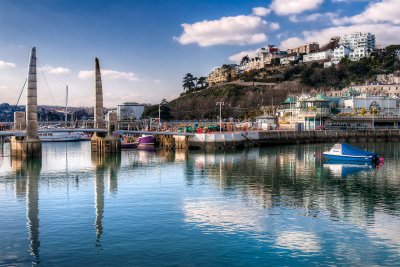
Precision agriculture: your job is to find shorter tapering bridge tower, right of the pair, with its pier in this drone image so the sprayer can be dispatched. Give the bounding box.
[91,58,121,154]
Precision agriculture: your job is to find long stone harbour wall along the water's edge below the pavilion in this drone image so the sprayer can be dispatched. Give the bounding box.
[183,129,400,149]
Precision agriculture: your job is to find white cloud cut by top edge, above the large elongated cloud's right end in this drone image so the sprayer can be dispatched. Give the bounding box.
[269,0,324,15]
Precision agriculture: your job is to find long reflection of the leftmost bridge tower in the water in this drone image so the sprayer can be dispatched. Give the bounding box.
[11,158,42,264]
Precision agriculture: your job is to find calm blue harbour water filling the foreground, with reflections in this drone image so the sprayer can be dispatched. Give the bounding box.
[0,142,400,266]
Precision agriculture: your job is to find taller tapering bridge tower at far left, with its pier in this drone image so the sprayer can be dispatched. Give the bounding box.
[11,47,42,158]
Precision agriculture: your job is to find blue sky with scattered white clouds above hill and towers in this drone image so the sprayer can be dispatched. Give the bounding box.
[0,0,400,107]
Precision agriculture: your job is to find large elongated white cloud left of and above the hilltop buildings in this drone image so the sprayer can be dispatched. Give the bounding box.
[174,15,279,46]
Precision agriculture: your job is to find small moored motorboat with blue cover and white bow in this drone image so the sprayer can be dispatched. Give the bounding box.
[324,144,380,162]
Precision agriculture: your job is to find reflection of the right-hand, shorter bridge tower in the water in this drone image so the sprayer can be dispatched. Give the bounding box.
[92,153,121,247]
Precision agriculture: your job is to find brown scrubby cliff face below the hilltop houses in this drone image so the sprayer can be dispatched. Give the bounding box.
[169,84,301,120]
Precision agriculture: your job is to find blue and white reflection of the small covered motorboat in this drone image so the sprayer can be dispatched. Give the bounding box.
[323,160,379,178]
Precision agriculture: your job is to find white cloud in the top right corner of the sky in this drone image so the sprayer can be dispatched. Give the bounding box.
[334,0,400,25]
